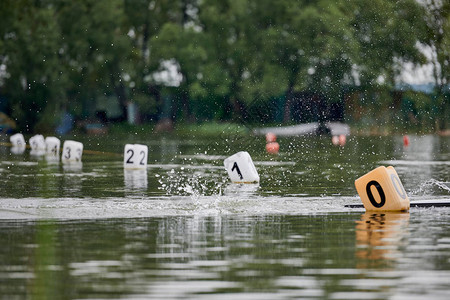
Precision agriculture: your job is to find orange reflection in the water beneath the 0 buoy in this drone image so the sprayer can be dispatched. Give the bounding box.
[355,212,410,269]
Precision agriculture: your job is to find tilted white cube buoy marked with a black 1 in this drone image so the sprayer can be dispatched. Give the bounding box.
[223,151,259,183]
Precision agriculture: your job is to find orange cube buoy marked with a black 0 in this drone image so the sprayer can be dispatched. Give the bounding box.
[355,166,410,211]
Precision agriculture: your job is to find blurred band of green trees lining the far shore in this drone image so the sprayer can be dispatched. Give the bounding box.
[0,0,450,132]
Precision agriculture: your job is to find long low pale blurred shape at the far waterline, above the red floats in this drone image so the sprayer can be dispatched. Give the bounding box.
[253,122,350,136]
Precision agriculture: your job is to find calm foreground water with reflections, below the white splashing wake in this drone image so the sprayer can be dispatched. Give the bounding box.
[0,213,450,299]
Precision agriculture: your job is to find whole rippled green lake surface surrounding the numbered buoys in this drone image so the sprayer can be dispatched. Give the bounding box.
[0,132,450,299]
